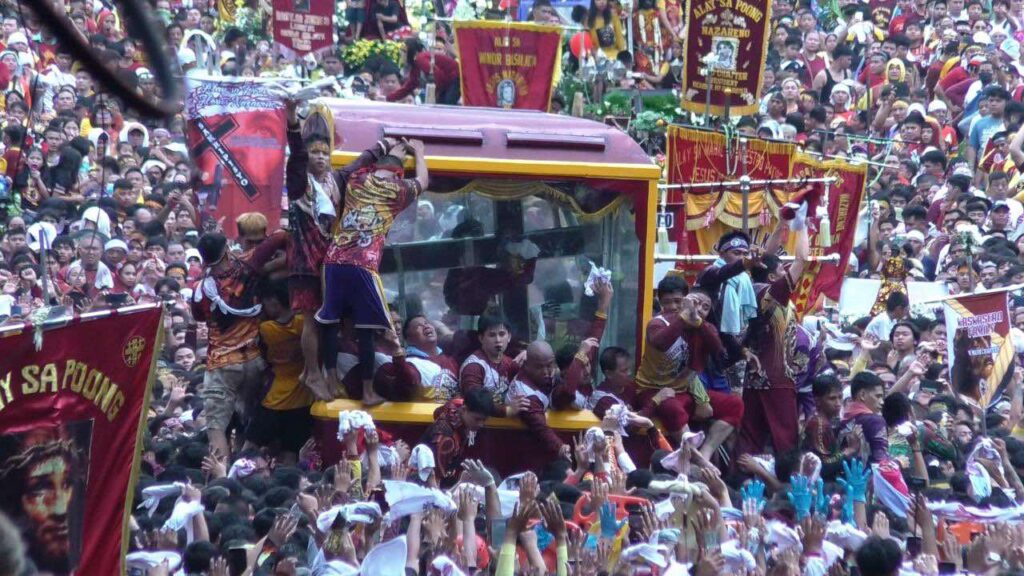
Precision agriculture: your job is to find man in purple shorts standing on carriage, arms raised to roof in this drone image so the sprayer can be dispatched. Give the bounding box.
[316,135,429,406]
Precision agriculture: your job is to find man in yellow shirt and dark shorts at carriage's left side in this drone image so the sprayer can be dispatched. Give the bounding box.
[246,281,313,465]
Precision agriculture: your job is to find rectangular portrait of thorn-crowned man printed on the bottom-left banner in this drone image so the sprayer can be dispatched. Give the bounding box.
[0,420,92,576]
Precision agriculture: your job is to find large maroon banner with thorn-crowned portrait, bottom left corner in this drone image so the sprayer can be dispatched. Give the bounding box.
[0,304,162,574]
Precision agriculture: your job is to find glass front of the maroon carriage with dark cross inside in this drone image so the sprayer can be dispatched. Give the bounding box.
[380,180,640,351]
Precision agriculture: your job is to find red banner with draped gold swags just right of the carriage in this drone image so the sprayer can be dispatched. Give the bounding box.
[666,125,796,260]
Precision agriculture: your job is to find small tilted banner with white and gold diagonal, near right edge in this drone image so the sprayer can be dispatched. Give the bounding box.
[943,291,1015,407]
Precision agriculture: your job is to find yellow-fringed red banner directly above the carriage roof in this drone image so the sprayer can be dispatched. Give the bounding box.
[454,20,562,112]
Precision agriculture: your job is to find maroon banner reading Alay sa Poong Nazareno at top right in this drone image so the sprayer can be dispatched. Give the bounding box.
[682,0,771,116]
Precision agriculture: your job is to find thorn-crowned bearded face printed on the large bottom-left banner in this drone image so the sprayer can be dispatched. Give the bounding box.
[22,456,75,567]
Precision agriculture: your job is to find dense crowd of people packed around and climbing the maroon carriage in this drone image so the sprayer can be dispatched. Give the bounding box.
[0,0,1024,576]
